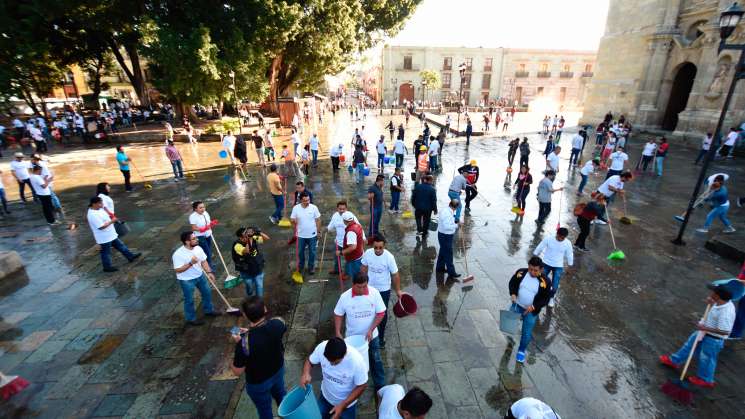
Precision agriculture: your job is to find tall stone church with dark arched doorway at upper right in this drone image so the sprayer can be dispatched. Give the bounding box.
[583,0,745,137]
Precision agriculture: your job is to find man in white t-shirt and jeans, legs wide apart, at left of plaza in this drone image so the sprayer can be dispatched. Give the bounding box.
[86,196,142,272]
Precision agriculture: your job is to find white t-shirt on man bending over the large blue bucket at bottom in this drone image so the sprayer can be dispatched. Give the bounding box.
[308,340,367,406]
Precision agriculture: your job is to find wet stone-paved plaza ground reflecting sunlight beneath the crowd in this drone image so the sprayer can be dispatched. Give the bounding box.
[0,112,745,418]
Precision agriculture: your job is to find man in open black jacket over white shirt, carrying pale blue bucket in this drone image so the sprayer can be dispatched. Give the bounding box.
[509,256,551,364]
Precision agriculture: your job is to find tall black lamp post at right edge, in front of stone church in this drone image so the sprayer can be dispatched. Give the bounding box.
[672,2,745,246]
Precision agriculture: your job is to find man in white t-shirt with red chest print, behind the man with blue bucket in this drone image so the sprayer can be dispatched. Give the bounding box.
[334,272,386,391]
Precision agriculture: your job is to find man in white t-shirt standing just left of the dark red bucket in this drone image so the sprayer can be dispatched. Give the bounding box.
[360,233,401,348]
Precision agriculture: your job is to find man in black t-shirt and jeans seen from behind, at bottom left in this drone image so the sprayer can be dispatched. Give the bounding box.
[230,296,287,419]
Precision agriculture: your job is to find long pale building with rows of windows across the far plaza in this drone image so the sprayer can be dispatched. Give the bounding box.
[380,45,595,108]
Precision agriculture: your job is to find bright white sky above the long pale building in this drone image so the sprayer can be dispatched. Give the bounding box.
[387,0,609,50]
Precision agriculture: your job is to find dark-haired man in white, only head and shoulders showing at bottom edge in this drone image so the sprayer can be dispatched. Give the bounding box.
[378,384,432,419]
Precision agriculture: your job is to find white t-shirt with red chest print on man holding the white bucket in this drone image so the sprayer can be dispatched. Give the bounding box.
[329,285,386,340]
